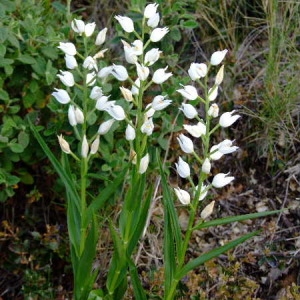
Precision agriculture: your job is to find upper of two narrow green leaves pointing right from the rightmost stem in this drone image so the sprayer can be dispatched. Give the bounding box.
[193,210,282,230]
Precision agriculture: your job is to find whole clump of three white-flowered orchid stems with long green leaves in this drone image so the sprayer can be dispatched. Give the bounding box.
[27,3,280,300]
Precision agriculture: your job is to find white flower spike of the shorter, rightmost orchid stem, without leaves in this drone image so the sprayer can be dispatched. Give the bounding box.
[174,50,240,219]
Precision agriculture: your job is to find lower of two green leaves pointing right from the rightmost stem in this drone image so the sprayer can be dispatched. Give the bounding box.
[176,231,260,280]
